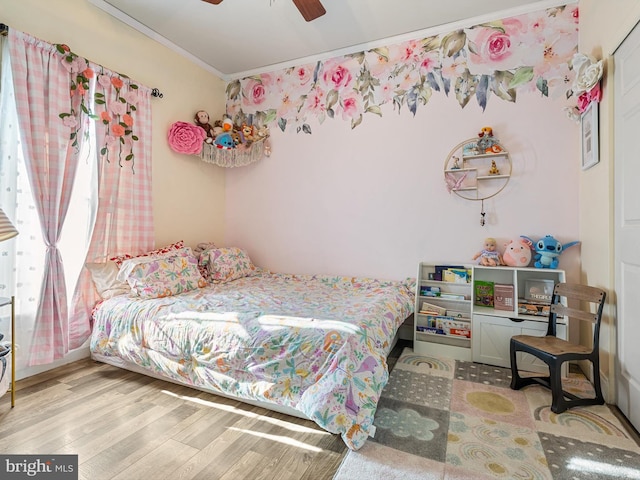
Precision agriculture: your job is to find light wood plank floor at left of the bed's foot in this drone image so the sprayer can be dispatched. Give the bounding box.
[0,359,347,480]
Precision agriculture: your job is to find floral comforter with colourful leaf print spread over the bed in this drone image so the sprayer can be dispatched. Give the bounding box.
[91,272,414,449]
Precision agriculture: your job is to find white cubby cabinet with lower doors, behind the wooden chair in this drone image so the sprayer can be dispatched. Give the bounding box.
[471,265,568,373]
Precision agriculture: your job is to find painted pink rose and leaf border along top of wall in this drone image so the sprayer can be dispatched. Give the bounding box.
[226,5,578,133]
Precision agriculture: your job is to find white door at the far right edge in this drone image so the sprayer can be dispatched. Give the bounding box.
[603,19,640,430]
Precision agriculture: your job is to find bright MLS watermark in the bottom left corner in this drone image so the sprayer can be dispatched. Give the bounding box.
[0,454,78,480]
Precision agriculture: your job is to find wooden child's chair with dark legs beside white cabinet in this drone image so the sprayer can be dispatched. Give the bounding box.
[510,283,606,413]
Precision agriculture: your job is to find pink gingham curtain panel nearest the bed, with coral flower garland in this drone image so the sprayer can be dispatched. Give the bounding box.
[70,64,154,348]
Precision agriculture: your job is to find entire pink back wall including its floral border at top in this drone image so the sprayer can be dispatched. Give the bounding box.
[225,5,580,280]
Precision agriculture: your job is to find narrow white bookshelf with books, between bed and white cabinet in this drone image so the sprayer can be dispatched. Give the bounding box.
[413,262,472,361]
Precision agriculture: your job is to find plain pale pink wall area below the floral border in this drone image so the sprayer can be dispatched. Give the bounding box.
[225,89,580,280]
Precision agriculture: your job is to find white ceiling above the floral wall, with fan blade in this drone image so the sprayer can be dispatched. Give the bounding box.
[88,0,573,80]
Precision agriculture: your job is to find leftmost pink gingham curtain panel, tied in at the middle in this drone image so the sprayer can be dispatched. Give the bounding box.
[9,29,86,365]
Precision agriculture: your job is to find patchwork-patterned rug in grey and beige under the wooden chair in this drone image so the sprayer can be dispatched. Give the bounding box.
[334,348,640,480]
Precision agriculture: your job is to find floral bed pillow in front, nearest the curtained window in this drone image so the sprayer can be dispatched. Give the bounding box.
[118,247,207,298]
